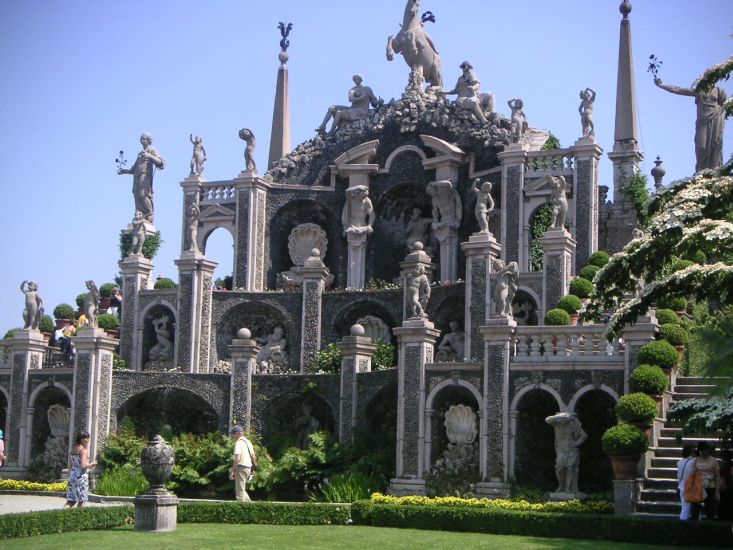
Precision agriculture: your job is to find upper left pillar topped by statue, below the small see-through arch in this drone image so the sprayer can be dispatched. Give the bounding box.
[173,253,219,372]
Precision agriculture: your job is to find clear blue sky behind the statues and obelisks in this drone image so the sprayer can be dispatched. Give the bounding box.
[0,0,733,332]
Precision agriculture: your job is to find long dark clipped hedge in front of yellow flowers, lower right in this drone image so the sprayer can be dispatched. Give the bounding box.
[351,501,733,547]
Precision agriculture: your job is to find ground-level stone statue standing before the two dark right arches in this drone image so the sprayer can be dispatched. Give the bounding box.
[545,412,588,495]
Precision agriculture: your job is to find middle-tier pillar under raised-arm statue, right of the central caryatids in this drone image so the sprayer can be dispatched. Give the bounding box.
[461,233,501,361]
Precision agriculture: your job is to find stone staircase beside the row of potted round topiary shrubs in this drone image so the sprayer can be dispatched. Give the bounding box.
[634,376,719,517]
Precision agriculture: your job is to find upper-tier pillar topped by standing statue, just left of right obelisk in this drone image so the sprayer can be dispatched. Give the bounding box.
[570,138,603,269]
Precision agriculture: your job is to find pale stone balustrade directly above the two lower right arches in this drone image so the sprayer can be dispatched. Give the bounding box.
[513,325,624,362]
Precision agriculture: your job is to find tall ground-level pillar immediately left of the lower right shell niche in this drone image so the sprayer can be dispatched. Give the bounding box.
[390,319,440,495]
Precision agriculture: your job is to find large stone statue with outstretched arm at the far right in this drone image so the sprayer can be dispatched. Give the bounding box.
[654,78,726,172]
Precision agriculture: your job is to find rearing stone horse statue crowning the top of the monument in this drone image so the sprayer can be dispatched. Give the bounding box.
[387,0,443,89]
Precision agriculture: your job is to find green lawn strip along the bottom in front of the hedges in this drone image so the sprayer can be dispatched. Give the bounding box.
[0,523,704,550]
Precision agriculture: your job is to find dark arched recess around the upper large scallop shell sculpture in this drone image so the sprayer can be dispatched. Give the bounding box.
[267,200,345,294]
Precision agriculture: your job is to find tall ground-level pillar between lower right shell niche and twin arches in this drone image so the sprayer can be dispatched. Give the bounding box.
[476,317,517,498]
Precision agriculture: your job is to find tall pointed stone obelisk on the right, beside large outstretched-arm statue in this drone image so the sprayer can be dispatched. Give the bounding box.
[608,0,644,202]
